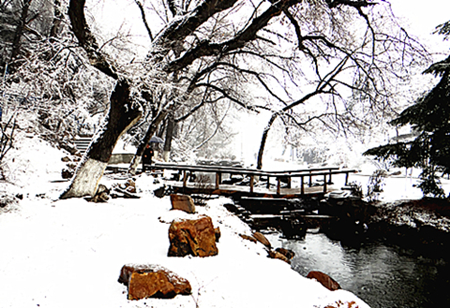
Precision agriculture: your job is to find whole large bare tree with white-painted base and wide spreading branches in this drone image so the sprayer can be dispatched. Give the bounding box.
[62,0,428,198]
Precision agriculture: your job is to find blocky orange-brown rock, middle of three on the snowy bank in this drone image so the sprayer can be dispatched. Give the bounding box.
[168,216,219,257]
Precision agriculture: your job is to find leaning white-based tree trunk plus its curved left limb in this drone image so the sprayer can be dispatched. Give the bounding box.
[60,0,142,199]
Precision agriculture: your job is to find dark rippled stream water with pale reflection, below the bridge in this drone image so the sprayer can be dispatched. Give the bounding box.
[268,233,450,308]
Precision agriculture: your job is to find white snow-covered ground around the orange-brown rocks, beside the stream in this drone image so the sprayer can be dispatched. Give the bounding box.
[0,135,368,308]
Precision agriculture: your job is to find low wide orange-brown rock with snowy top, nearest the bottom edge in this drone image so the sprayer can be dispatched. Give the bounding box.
[119,265,192,300]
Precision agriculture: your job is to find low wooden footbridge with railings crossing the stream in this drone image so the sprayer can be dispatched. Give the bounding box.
[146,163,357,197]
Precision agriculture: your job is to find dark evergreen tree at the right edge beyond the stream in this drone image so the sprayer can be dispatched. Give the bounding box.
[364,21,450,197]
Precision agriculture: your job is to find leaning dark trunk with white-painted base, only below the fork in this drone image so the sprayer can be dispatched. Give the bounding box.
[60,81,142,199]
